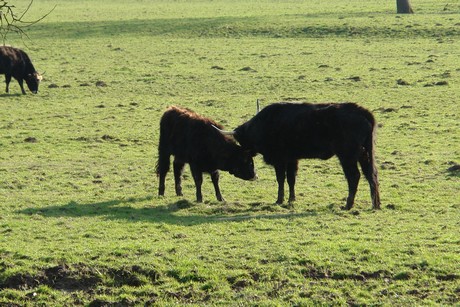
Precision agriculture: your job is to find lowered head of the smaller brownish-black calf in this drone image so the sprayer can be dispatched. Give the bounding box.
[227,144,257,180]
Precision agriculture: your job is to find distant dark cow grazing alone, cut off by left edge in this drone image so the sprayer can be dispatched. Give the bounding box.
[0,46,42,94]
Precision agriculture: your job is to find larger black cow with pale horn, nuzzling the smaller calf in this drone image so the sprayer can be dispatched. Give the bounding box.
[217,103,380,210]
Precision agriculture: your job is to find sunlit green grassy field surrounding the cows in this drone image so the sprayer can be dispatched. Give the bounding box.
[0,0,460,306]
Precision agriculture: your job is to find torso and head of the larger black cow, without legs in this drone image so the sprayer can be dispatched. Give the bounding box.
[235,102,375,164]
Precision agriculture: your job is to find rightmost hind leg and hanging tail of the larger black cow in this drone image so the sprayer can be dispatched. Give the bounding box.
[359,113,380,209]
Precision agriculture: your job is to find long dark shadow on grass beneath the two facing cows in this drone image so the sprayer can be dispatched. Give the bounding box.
[17,196,318,226]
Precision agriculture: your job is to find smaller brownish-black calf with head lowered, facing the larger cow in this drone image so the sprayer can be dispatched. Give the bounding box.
[156,106,256,202]
